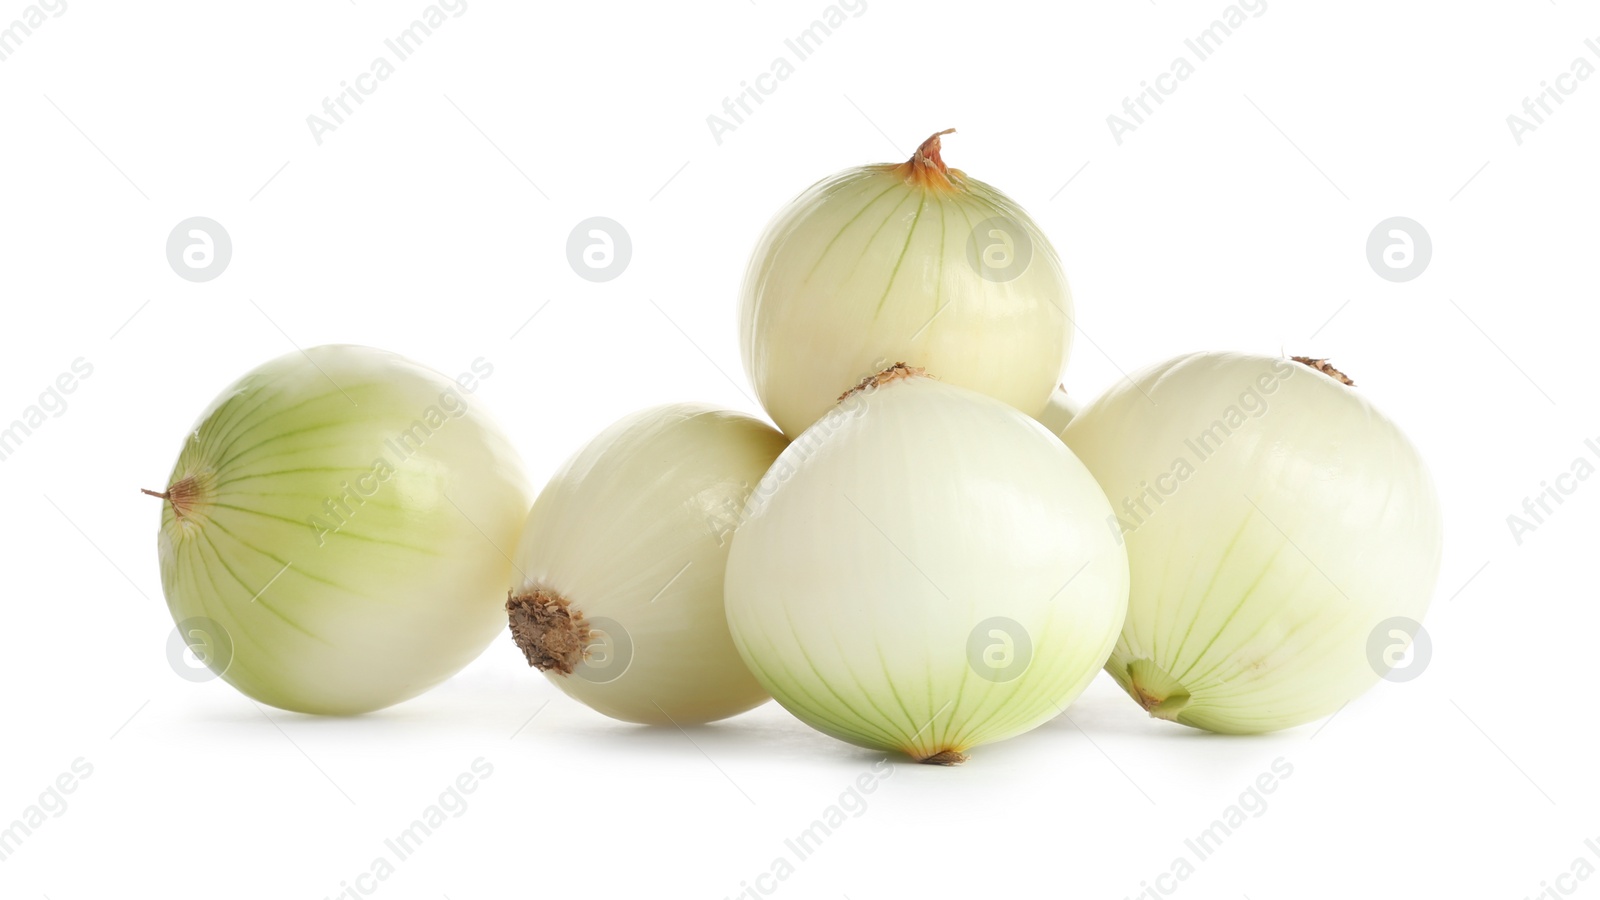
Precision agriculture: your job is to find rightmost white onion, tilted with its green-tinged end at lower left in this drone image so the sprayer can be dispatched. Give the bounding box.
[1062,352,1443,733]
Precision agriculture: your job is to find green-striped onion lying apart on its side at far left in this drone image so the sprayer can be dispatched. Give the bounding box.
[158,346,531,714]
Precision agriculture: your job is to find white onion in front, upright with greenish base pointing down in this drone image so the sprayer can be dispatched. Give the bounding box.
[726,367,1128,764]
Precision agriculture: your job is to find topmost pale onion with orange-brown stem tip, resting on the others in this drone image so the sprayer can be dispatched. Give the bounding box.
[739,131,1072,437]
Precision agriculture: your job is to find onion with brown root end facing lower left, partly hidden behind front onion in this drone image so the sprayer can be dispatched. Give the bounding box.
[506,404,787,724]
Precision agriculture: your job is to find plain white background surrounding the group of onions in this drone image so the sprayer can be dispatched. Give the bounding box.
[0,0,1600,900]
